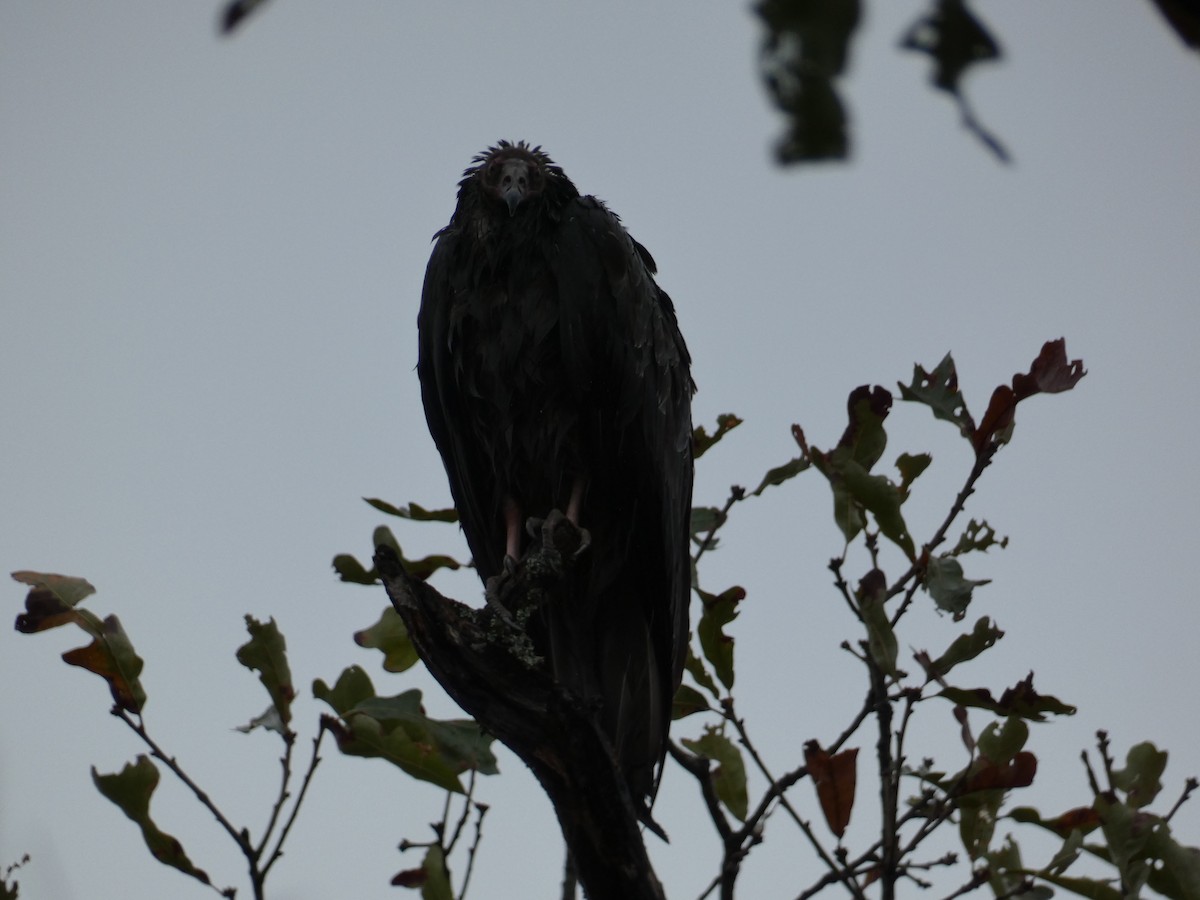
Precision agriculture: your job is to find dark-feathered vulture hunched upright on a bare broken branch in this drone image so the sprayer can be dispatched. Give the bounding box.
[418,140,695,822]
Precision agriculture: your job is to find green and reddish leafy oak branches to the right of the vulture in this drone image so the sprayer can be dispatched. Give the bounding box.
[672,341,1200,899]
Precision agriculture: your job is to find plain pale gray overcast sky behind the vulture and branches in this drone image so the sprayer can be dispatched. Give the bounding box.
[0,0,1200,900]
